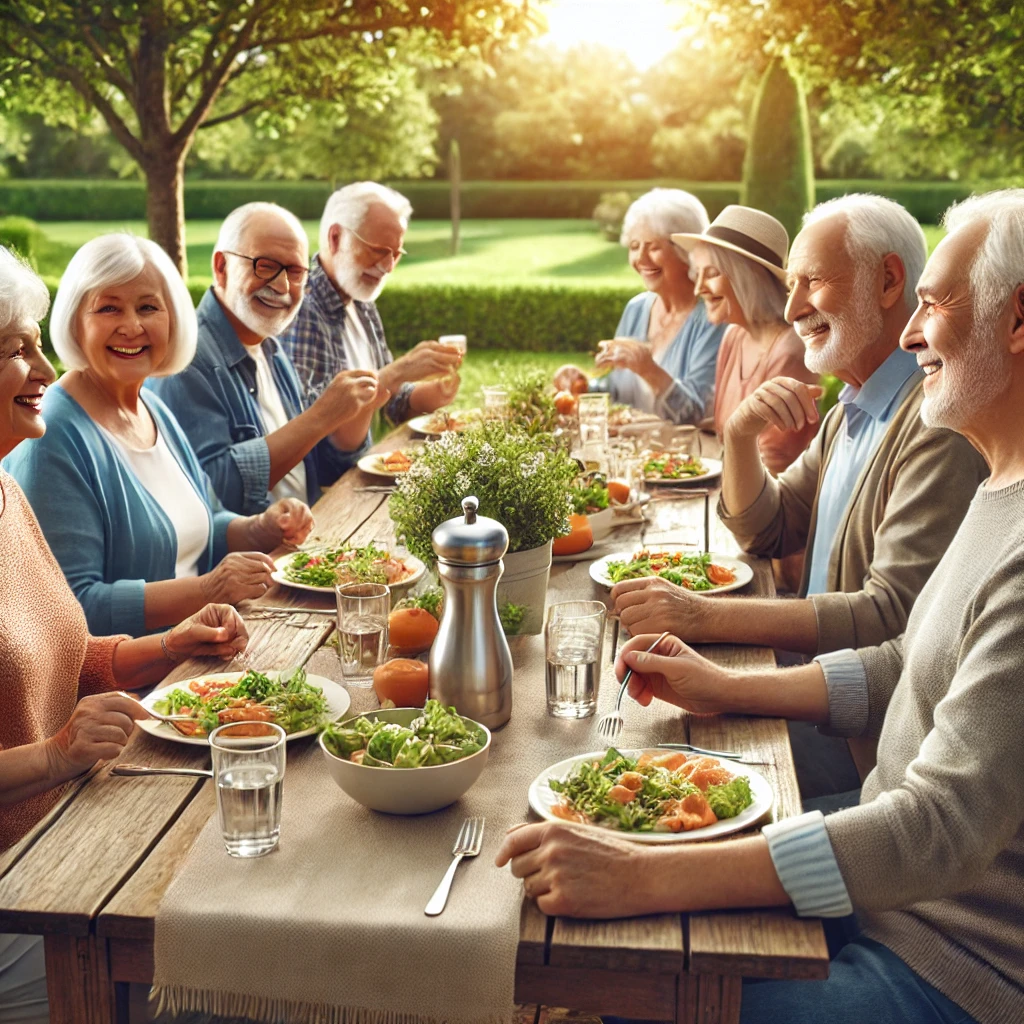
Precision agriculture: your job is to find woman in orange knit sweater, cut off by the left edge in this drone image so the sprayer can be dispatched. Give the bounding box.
[0,247,246,1024]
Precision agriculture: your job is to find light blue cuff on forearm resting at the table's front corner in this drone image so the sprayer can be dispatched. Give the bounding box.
[761,811,853,918]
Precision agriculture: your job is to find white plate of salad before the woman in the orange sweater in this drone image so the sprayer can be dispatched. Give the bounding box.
[138,669,350,746]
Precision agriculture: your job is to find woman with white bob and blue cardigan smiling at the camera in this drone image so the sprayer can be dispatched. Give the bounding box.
[4,233,312,636]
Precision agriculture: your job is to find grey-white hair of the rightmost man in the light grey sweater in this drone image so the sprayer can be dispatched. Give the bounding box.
[942,188,1024,325]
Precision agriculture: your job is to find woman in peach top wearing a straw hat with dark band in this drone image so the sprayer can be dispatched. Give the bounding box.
[672,206,818,474]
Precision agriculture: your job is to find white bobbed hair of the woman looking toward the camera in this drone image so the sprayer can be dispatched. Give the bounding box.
[50,231,198,377]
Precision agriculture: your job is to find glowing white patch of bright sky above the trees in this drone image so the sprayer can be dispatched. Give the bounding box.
[543,0,680,69]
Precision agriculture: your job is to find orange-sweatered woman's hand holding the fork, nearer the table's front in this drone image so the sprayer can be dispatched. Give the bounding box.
[47,693,150,779]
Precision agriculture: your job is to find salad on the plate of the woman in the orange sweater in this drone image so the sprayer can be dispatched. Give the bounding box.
[153,669,329,736]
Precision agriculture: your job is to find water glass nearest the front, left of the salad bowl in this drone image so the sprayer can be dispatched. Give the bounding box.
[210,722,285,857]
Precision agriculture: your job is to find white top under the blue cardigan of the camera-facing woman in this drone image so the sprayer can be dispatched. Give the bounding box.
[99,417,210,579]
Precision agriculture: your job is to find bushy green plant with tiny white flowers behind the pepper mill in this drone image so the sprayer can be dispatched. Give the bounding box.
[388,423,580,565]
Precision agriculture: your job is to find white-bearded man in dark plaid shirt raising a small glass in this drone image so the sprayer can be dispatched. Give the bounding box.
[281,181,462,460]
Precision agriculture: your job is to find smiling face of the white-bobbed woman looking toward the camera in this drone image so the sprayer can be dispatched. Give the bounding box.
[75,265,171,384]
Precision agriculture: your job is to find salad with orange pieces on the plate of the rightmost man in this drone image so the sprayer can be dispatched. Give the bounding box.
[548,746,754,833]
